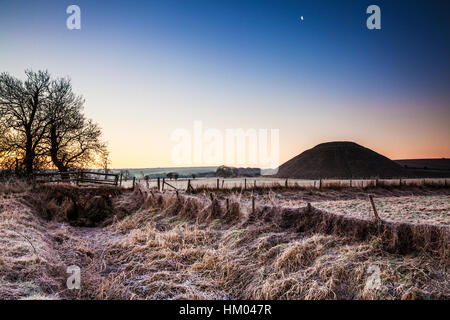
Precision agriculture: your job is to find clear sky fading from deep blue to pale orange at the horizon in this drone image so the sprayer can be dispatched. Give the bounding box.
[0,0,450,168]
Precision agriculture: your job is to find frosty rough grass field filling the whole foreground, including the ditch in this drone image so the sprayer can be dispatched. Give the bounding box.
[0,181,450,299]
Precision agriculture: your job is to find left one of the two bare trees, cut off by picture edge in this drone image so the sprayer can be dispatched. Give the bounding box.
[0,70,50,174]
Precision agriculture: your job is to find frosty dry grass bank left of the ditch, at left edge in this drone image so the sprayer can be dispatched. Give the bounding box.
[0,188,65,299]
